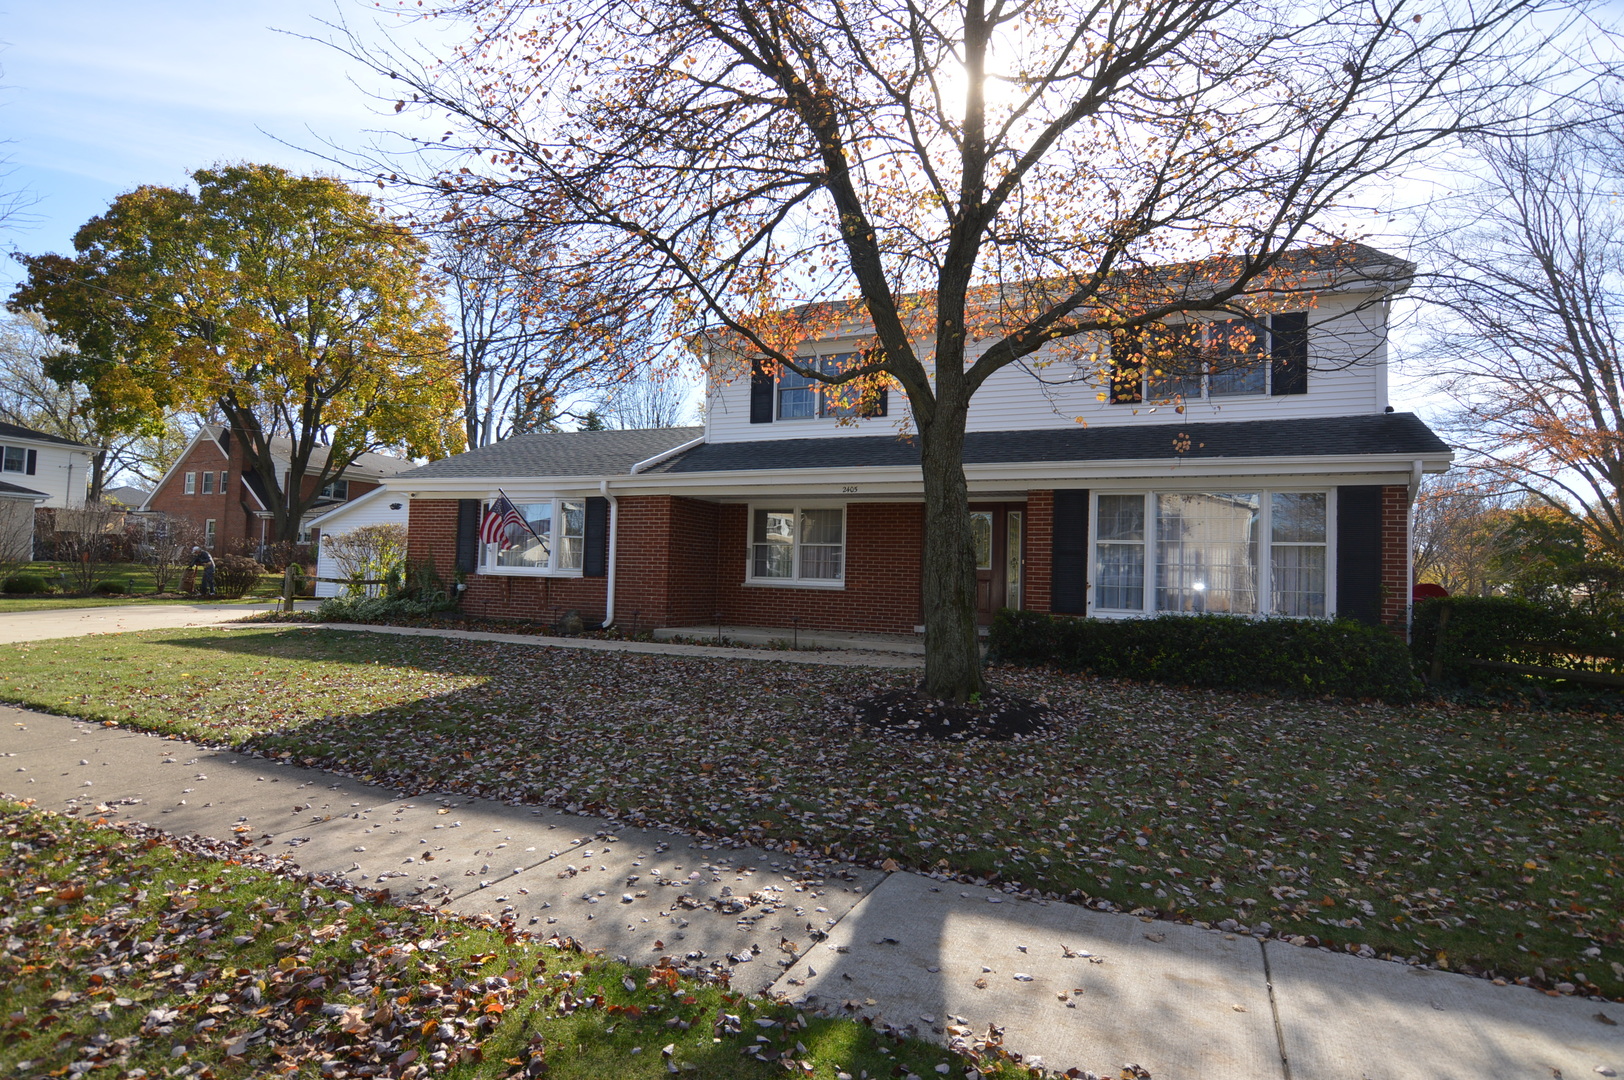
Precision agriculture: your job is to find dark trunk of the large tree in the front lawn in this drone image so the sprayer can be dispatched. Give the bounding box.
[919,400,983,703]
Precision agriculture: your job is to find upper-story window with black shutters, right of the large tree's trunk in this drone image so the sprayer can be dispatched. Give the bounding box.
[1111,312,1309,404]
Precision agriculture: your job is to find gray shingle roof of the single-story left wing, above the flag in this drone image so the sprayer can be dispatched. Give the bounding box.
[396,427,705,482]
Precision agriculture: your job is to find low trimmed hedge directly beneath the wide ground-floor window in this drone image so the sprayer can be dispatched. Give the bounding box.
[989,609,1421,702]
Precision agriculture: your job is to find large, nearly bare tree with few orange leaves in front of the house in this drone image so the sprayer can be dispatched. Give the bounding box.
[341,0,1574,700]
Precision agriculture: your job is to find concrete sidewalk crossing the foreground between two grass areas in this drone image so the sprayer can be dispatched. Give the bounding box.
[0,708,1624,1080]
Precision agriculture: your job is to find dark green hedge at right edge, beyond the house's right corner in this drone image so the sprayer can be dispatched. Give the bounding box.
[1410,596,1624,684]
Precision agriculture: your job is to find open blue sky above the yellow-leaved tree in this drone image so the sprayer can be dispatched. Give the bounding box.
[0,0,431,291]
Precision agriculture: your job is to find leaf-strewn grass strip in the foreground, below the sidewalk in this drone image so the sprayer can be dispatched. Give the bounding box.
[0,802,1025,1080]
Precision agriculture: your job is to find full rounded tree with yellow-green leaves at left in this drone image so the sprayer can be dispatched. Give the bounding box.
[10,164,463,541]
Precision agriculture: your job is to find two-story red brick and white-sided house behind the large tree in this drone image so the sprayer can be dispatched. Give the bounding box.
[390,248,1450,633]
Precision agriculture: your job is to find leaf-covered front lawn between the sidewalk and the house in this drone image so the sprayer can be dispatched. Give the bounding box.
[0,627,1624,997]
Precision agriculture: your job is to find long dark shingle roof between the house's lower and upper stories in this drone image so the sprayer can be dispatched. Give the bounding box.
[646,413,1449,474]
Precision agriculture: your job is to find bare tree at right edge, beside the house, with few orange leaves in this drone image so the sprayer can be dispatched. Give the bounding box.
[1423,115,1624,560]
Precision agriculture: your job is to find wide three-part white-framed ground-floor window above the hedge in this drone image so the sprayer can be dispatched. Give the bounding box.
[1088,490,1335,617]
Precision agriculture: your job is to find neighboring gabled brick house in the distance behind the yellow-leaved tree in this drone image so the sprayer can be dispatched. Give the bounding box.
[141,424,416,554]
